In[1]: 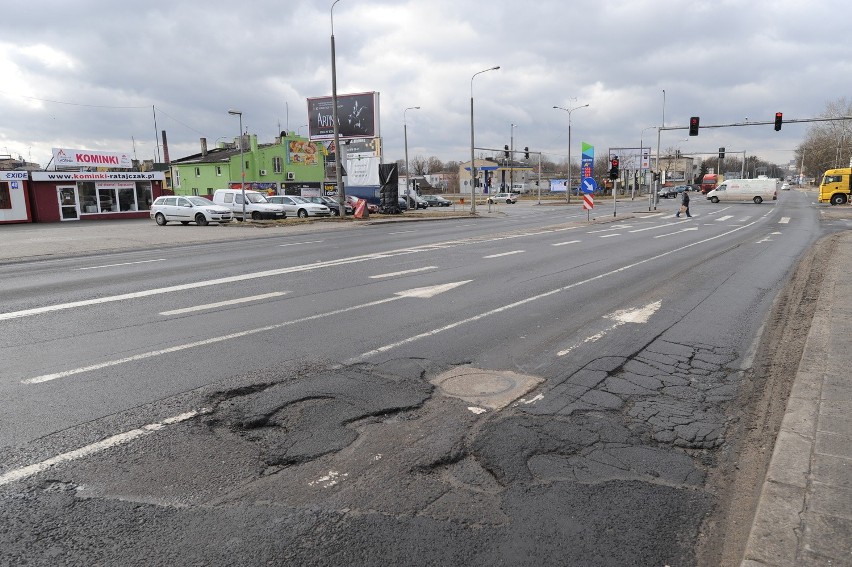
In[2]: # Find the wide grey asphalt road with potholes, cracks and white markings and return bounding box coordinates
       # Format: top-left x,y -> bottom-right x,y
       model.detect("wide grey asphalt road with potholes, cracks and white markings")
0,192 -> 840,565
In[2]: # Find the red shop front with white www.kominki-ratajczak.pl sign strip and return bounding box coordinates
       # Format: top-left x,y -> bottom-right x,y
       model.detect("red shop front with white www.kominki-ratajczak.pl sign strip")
30,171 -> 165,222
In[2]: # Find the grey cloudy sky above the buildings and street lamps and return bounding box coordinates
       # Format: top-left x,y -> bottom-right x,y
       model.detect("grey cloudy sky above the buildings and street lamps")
0,0 -> 852,171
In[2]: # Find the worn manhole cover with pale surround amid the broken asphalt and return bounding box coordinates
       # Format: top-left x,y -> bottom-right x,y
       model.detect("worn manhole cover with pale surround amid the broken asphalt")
431,367 -> 542,409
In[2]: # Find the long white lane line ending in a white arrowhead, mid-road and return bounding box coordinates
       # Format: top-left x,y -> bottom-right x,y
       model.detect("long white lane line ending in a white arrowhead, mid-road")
21,280 -> 473,384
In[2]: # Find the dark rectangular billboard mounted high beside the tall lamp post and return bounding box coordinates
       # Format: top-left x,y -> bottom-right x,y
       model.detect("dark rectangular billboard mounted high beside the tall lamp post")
308,92 -> 379,140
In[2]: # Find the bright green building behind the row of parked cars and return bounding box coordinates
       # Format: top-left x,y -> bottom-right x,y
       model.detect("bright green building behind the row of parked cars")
170,132 -> 325,196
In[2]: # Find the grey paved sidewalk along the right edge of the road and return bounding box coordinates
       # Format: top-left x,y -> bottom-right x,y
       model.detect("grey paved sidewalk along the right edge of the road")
740,231 -> 852,567
